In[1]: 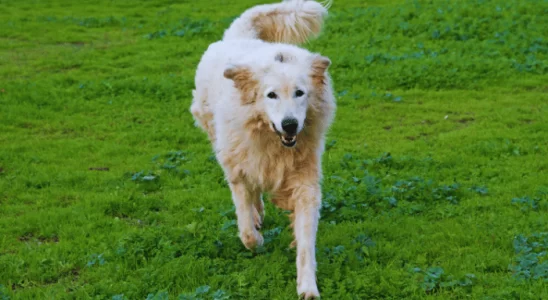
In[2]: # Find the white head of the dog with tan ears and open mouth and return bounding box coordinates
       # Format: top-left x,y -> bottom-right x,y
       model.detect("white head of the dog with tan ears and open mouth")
224,53 -> 331,147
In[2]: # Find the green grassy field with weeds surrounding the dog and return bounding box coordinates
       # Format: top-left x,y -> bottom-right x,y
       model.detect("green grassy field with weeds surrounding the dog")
0,0 -> 548,299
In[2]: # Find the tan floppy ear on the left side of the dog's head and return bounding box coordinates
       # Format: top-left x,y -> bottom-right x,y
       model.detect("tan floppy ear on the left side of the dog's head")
223,66 -> 259,104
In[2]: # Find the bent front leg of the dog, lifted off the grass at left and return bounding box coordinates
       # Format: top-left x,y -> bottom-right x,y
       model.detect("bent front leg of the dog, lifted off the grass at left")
230,182 -> 263,249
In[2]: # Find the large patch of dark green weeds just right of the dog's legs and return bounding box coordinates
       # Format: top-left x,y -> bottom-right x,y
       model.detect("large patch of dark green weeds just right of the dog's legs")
322,153 -> 465,221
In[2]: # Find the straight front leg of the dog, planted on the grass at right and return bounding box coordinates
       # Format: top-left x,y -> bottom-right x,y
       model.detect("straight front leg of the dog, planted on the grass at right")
293,185 -> 321,299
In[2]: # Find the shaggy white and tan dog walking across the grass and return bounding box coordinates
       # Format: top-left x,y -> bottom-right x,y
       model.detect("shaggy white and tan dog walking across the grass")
190,0 -> 335,298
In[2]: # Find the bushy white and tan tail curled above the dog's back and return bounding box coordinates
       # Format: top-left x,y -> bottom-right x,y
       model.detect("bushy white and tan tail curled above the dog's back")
223,0 -> 332,44
